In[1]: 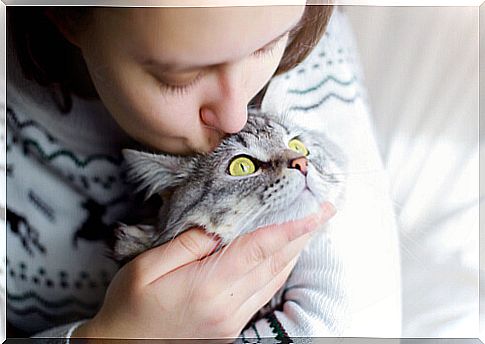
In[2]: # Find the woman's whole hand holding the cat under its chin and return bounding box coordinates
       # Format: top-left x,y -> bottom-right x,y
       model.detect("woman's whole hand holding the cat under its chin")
73,203 -> 335,338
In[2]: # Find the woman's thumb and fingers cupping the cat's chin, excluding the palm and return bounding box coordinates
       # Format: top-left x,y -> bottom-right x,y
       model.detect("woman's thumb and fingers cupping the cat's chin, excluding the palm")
134,203 -> 335,306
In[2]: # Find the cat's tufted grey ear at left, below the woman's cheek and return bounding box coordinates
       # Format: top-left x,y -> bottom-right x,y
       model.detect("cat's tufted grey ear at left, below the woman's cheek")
122,149 -> 193,198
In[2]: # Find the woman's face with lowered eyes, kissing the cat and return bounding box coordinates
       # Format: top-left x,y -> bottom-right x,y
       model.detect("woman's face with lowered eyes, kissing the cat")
73,6 -> 304,154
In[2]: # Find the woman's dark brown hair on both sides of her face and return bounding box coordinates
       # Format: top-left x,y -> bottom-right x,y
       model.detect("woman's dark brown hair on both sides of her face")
7,5 -> 333,113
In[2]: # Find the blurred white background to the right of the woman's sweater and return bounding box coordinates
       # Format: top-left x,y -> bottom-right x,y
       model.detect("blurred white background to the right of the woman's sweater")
342,5 -> 484,338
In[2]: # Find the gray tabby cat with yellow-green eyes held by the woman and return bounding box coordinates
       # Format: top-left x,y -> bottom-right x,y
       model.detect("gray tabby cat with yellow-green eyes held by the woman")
114,112 -> 344,260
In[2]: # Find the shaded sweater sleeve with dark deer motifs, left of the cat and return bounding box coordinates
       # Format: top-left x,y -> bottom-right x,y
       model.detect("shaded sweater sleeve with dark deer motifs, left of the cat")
4,18 -> 130,338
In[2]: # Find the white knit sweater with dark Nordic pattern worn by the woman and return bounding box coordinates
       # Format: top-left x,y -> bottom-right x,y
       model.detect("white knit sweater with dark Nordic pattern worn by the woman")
7,11 -> 400,342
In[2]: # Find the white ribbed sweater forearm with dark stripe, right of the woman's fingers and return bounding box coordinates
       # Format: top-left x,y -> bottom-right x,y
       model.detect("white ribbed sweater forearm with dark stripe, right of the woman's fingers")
238,233 -> 347,343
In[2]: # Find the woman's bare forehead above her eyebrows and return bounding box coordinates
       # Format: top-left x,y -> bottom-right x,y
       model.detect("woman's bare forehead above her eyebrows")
97,6 -> 304,70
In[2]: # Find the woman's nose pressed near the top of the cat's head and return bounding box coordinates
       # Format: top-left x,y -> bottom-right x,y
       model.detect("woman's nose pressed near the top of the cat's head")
200,63 -> 249,134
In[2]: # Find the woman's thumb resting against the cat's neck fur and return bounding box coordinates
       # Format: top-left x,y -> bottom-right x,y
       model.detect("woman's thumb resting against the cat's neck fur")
132,227 -> 219,284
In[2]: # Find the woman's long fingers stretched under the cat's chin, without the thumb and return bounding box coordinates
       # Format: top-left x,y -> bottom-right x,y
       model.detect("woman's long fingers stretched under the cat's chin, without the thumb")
158,205 -> 334,307
